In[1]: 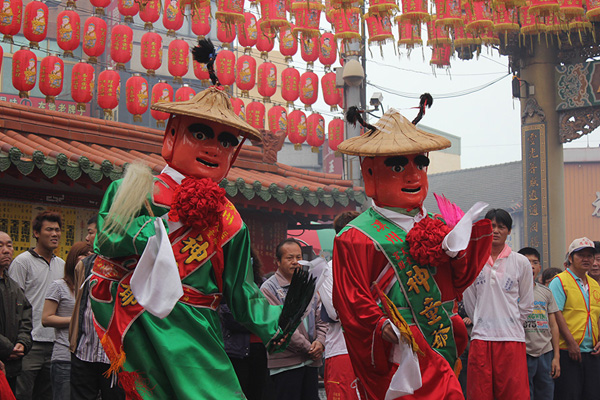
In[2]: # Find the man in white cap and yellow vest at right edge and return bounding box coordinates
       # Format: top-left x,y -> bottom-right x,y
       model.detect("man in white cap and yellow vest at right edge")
549,237 -> 600,400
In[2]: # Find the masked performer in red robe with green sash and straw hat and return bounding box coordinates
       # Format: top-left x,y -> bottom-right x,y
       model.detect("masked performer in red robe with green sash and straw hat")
333,109 -> 491,400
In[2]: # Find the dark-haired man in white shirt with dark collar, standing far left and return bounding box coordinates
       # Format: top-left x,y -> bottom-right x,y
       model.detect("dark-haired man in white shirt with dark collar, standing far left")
8,211 -> 65,400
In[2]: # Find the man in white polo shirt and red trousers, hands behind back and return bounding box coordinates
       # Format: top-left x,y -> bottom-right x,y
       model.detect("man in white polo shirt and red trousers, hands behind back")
463,209 -> 533,400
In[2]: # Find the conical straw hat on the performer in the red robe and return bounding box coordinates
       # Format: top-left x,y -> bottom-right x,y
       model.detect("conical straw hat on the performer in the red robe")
338,108 -> 451,157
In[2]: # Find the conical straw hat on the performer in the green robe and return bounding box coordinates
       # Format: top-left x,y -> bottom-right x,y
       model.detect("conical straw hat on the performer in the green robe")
152,86 -> 262,140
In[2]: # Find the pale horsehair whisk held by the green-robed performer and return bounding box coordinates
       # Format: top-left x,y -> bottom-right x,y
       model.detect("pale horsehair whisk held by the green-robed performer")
98,161 -> 154,245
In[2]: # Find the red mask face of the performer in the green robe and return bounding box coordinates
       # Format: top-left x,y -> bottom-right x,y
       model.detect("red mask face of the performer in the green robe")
162,115 -> 239,182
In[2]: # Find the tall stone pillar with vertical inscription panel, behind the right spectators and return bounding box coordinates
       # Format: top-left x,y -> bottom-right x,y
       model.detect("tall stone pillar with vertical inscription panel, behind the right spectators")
516,41 -> 566,269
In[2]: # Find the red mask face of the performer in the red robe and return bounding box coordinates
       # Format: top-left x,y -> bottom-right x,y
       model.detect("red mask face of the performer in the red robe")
361,153 -> 429,211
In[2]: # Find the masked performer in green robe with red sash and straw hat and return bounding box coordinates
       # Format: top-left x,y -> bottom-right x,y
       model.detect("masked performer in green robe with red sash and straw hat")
90,42 -> 312,400
